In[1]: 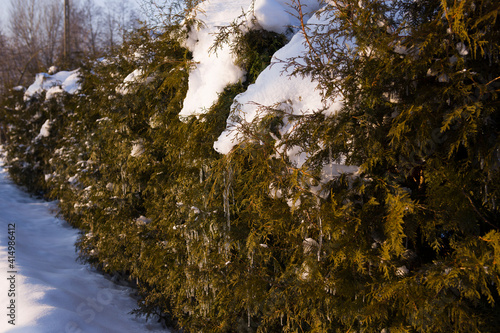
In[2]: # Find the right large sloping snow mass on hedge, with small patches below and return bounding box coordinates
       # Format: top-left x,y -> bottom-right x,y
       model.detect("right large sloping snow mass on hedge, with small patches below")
210,6 -> 359,201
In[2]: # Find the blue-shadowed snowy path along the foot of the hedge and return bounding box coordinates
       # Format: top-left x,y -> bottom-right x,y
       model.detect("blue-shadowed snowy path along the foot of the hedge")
0,156 -> 168,333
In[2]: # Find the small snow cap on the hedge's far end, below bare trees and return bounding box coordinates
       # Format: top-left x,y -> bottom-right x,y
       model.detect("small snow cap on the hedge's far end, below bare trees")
24,70 -> 80,101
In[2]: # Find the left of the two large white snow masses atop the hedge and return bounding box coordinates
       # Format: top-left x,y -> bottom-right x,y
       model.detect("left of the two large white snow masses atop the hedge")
179,0 -> 322,117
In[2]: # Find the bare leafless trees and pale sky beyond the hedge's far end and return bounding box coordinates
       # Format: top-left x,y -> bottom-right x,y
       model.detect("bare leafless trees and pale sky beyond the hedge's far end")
0,0 -> 141,94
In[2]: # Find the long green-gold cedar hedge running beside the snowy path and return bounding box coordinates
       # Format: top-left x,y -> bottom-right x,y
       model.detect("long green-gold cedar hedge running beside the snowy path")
0,0 -> 500,332
